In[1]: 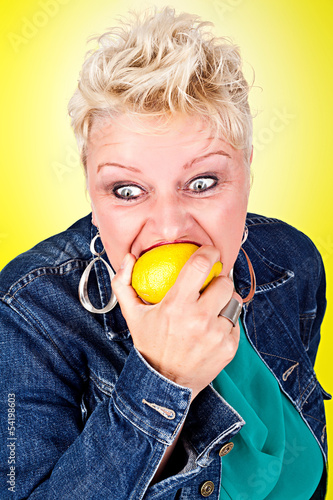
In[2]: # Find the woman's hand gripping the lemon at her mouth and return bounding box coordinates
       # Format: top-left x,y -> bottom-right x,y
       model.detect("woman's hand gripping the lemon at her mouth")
112,246 -> 242,398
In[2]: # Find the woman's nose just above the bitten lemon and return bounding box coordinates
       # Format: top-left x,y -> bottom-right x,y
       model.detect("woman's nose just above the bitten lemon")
146,196 -> 195,241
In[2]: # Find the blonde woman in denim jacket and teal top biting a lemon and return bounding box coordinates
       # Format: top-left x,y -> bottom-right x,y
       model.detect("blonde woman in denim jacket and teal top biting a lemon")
0,8 -> 328,500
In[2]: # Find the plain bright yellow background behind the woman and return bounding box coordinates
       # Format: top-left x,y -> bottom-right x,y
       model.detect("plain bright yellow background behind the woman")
0,0 -> 333,498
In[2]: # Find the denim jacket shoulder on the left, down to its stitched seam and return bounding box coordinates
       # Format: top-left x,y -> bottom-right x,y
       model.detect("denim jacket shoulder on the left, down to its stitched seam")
0,215 -> 91,298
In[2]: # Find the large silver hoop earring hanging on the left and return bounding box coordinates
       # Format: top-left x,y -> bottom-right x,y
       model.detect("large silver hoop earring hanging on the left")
79,233 -> 117,314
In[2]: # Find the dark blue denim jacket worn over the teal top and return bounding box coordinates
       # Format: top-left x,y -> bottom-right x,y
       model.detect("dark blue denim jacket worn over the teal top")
0,214 -> 329,500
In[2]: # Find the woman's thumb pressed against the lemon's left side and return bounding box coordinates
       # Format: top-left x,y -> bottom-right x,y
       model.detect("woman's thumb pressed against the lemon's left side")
112,253 -> 142,319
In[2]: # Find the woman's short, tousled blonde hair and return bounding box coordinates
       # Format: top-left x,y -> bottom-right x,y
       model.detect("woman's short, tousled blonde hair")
68,7 -> 252,165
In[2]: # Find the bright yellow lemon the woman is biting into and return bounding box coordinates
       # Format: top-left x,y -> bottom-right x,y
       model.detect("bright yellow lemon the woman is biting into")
132,243 -> 222,304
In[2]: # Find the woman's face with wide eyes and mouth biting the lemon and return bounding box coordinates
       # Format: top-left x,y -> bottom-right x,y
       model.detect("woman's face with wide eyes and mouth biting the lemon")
87,115 -> 250,275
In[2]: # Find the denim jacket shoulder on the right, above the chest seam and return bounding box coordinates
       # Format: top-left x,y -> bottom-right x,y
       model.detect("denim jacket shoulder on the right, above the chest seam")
246,213 -> 324,286
